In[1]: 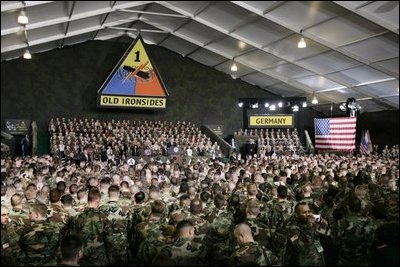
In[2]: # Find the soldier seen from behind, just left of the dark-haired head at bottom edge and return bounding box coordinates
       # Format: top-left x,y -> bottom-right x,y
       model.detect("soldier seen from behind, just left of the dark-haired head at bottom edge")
19,203 -> 60,266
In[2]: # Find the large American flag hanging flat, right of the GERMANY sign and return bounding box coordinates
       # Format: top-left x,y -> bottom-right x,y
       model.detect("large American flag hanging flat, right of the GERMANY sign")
314,117 -> 357,151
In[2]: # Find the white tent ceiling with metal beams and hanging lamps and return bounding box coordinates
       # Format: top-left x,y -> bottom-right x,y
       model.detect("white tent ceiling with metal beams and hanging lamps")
1,1 -> 399,112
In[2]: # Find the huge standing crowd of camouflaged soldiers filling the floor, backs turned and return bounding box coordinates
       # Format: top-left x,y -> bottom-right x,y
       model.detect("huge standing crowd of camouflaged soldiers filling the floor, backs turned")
1,148 -> 399,266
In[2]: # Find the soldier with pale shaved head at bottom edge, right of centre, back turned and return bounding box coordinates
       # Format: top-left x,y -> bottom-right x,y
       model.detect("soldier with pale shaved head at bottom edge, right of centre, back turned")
231,223 -> 279,266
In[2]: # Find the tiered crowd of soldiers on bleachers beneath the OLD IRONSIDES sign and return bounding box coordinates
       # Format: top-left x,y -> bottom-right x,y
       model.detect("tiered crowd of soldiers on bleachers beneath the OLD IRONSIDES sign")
49,118 -> 222,164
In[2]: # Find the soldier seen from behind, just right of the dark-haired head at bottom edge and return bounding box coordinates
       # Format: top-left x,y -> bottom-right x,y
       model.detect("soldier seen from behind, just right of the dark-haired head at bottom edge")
66,188 -> 110,266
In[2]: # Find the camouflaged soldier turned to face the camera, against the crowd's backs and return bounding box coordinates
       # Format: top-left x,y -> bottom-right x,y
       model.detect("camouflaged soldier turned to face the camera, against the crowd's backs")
283,202 -> 325,266
